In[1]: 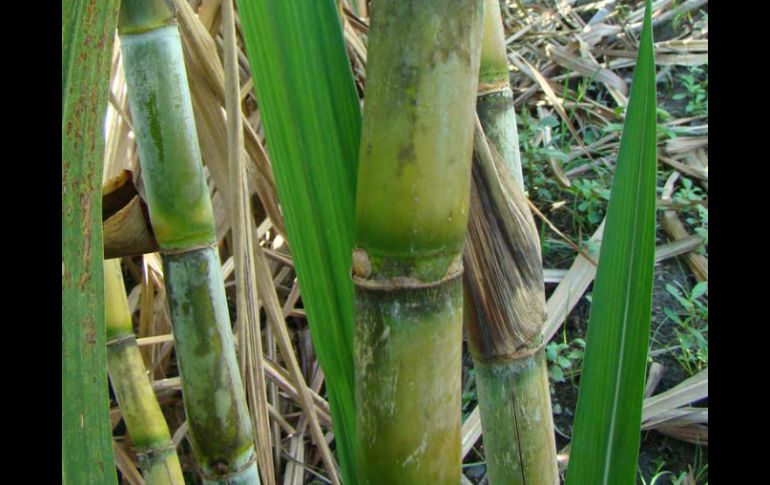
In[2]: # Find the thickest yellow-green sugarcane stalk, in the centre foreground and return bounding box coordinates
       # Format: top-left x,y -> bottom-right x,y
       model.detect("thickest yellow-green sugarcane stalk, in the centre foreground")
353,0 -> 483,484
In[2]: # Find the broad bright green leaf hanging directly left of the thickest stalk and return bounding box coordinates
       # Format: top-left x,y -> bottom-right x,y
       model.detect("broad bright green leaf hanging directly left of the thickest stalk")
238,0 -> 361,484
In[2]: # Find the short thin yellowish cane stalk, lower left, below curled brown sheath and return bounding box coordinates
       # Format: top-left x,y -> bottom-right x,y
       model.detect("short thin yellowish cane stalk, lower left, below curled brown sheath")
104,259 -> 184,485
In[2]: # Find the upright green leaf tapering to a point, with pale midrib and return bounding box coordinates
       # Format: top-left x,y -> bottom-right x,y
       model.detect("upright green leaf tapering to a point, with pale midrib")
567,0 -> 656,485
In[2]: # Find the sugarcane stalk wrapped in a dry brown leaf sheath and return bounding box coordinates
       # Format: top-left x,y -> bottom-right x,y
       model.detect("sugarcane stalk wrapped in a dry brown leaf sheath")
465,0 -> 559,485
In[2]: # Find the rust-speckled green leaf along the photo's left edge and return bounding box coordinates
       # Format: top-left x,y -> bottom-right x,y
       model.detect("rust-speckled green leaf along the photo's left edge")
62,0 -> 118,484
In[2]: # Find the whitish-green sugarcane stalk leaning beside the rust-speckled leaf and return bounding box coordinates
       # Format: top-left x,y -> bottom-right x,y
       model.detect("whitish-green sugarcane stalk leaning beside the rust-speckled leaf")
118,0 -> 259,484
